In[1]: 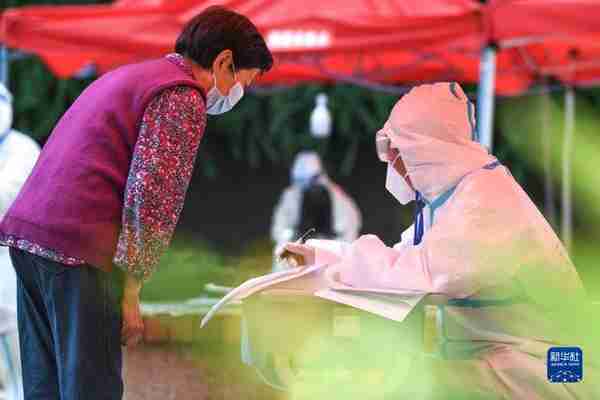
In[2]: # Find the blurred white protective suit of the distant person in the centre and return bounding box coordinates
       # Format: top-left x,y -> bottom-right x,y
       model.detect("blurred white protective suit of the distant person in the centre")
271,152 -> 362,244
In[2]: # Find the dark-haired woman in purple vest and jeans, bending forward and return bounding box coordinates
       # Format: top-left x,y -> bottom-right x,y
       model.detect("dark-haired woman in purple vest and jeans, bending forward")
0,6 -> 273,400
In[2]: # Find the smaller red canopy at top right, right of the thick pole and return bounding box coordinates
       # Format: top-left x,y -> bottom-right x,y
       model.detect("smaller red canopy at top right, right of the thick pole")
486,0 -> 600,85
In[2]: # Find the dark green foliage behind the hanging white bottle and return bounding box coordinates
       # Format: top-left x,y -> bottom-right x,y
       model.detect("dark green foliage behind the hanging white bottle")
210,85 -> 397,174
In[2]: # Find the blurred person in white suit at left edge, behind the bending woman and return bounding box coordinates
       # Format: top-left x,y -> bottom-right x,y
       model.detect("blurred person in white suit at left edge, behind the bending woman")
0,84 -> 40,400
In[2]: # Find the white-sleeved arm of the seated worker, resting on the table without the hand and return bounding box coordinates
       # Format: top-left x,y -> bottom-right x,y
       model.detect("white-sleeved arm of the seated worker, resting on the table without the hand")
332,178 -> 540,297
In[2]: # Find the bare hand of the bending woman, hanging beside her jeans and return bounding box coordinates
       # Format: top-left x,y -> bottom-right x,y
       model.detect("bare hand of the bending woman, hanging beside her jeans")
121,275 -> 144,347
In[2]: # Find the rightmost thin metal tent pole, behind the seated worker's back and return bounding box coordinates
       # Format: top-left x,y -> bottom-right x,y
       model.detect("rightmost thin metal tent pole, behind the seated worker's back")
562,85 -> 575,252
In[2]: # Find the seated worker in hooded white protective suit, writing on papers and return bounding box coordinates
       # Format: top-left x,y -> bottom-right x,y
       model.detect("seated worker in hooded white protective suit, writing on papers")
286,83 -> 600,400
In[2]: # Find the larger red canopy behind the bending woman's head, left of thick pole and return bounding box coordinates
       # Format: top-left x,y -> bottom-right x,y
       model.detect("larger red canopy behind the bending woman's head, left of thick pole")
0,0 -> 481,87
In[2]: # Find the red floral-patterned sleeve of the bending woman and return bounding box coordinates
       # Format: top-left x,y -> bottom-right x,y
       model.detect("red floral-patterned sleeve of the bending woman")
113,86 -> 206,280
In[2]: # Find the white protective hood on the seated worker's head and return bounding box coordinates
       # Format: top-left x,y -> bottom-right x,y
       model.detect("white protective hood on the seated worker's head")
383,82 -> 494,201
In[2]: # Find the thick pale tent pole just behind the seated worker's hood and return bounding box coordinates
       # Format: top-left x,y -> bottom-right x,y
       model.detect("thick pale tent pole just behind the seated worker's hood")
477,45 -> 496,153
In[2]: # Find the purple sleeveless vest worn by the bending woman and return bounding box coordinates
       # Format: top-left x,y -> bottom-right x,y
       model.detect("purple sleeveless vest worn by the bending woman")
0,58 -> 204,271
